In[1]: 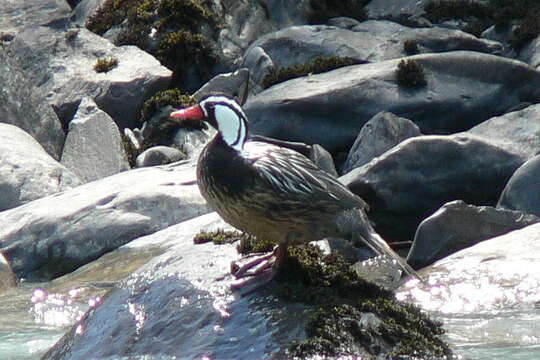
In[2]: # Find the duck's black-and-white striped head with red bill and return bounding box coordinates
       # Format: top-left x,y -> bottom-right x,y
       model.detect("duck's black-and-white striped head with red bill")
170,95 -> 248,151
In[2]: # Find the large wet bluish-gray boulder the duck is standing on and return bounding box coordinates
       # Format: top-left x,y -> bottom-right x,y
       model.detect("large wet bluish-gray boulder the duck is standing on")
42,214 -> 451,360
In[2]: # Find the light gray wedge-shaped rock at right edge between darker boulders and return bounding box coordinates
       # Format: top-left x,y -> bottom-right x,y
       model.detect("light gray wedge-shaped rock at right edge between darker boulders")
467,104 -> 540,157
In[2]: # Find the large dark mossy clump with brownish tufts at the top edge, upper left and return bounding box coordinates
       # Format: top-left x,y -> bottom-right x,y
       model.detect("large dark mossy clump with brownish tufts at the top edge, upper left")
86,0 -> 219,91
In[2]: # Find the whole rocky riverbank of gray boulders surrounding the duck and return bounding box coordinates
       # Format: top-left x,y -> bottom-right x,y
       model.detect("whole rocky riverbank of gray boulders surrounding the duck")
0,0 -> 540,360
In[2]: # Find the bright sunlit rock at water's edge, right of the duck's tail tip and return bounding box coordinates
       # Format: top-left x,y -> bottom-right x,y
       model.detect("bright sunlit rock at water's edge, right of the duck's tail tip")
396,223 -> 540,312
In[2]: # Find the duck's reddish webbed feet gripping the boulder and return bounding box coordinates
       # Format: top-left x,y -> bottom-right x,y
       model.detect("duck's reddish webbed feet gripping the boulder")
231,245 -> 287,293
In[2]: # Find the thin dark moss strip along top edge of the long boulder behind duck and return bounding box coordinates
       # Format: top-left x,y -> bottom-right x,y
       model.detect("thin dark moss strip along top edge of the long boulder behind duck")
262,56 -> 361,89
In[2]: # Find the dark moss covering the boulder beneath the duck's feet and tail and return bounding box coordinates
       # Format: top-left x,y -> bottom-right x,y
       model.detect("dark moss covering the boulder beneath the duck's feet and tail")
202,230 -> 452,360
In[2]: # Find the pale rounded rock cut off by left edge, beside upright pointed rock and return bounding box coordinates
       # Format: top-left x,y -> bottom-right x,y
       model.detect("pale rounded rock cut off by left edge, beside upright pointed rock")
0,124 -> 80,211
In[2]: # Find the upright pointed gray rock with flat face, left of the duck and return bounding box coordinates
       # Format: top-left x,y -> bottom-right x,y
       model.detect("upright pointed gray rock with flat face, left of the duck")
62,97 -> 130,183
